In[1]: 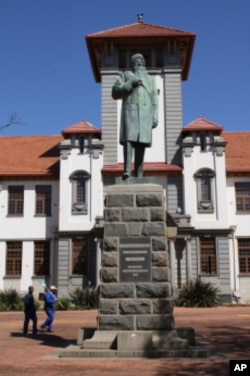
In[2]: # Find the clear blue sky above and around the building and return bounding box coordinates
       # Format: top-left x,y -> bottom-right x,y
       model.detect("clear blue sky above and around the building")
0,0 -> 250,135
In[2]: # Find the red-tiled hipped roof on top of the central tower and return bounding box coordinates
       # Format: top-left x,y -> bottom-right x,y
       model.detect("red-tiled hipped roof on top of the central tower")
86,19 -> 195,82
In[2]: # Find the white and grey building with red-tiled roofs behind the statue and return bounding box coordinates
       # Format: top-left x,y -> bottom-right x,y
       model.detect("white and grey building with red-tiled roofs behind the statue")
0,19 -> 250,302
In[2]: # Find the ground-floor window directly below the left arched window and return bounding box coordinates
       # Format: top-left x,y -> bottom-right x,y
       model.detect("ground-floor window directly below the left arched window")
71,238 -> 88,275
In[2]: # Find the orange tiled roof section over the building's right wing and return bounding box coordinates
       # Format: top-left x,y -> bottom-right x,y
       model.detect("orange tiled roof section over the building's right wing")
224,132 -> 250,174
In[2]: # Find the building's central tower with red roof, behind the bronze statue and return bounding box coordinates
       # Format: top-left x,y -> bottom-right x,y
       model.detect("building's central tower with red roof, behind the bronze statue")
86,15 -> 195,212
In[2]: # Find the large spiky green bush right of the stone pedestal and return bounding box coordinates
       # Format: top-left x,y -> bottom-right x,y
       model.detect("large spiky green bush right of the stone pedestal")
175,278 -> 220,307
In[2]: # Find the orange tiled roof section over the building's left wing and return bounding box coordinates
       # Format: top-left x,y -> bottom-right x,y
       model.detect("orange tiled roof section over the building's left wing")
0,136 -> 63,179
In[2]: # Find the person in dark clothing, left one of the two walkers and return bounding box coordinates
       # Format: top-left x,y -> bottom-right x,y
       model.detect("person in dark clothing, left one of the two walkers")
23,286 -> 39,336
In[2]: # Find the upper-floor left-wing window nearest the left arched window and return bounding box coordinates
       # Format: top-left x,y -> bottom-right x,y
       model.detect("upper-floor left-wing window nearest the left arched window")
35,184 -> 52,217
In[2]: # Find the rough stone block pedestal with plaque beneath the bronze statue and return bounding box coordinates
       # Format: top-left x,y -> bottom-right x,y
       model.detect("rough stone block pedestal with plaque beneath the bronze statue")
98,183 -> 174,331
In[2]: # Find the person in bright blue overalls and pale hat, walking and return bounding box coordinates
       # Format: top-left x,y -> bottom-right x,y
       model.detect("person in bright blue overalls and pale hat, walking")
41,286 -> 57,332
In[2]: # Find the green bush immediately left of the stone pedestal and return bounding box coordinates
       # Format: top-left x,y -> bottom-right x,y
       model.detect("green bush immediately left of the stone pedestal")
69,287 -> 99,309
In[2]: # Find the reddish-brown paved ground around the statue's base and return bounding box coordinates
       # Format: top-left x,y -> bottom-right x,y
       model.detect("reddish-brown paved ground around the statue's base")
0,306 -> 250,376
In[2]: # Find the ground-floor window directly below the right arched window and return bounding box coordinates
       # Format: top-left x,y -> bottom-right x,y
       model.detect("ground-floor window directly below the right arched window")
200,237 -> 217,275
